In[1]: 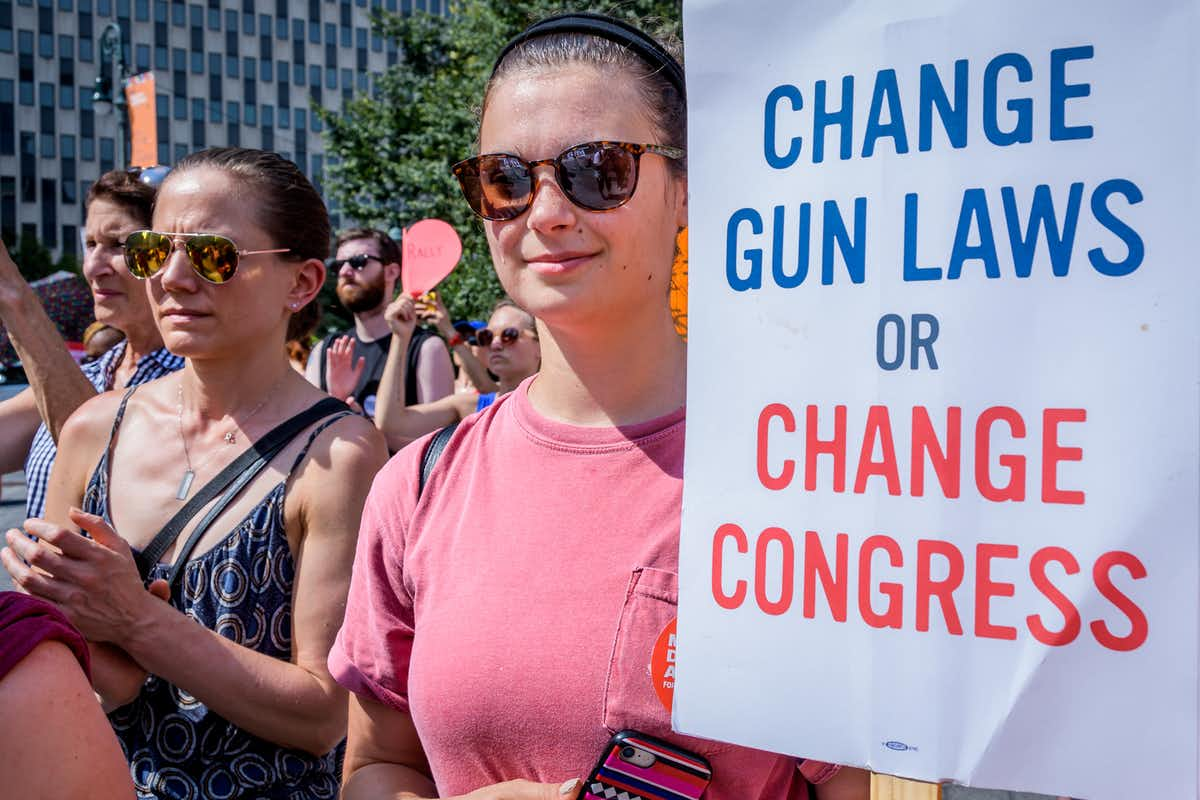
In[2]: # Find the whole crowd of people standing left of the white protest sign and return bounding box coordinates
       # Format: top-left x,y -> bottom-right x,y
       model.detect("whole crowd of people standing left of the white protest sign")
0,14 -> 869,800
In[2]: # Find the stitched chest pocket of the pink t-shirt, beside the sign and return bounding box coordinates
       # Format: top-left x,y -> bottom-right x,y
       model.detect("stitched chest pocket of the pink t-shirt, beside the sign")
604,567 -> 734,756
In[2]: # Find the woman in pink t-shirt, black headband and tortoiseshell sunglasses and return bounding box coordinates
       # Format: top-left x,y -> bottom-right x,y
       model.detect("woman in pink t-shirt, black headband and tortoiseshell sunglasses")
330,14 -> 869,800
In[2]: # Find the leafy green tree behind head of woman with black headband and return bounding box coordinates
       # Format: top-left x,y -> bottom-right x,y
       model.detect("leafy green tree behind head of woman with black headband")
314,0 -> 680,326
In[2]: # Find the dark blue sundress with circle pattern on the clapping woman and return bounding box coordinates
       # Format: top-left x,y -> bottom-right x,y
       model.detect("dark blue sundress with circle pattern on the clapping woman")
83,390 -> 344,800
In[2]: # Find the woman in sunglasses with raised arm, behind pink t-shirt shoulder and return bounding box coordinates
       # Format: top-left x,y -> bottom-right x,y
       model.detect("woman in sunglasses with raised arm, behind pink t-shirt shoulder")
376,295 -> 541,451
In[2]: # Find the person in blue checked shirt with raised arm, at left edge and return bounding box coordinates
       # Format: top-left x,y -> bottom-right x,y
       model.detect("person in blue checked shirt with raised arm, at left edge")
0,169 -> 184,517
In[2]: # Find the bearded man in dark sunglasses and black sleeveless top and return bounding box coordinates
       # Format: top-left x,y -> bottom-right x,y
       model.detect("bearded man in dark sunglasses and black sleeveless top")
305,228 -> 454,417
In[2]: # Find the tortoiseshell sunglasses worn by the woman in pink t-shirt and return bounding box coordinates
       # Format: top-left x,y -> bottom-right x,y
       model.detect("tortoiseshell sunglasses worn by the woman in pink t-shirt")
451,142 -> 684,221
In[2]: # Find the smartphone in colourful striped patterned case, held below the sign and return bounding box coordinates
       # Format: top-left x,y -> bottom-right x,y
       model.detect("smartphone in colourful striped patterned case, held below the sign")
580,730 -> 713,800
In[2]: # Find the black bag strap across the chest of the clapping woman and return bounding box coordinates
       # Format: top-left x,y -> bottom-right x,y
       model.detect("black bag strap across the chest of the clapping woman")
133,397 -> 347,581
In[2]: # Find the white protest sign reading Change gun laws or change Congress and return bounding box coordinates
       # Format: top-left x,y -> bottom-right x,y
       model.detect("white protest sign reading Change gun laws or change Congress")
674,0 -> 1200,800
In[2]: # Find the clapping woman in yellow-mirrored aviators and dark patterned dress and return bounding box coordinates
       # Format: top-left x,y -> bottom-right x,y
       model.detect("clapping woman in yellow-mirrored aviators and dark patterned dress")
4,148 -> 386,798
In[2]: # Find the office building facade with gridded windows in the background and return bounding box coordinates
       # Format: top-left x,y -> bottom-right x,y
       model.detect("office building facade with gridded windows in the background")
0,0 -> 448,257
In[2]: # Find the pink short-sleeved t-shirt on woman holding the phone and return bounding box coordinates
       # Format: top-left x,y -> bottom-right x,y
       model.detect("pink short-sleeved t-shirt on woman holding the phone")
329,380 -> 817,800
